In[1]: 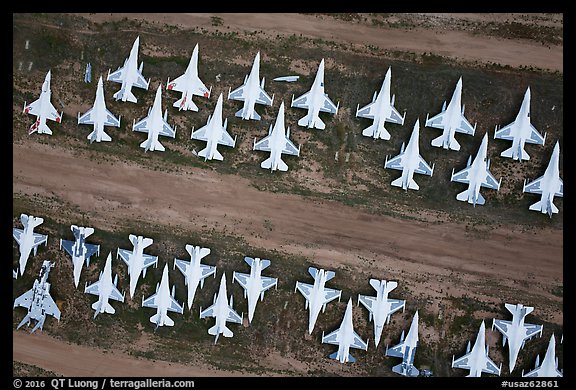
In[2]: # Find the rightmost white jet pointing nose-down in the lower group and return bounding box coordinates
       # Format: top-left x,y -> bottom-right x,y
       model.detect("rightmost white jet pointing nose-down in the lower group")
492,303 -> 543,372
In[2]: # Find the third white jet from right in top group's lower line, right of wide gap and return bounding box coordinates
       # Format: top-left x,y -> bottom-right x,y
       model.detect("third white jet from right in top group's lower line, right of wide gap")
384,119 -> 434,191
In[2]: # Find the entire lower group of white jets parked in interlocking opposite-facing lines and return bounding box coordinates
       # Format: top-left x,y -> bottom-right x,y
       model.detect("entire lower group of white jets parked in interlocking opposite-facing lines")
13,214 -> 562,377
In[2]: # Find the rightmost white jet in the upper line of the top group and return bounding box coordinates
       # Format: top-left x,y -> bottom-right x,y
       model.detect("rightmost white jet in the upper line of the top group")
494,87 -> 546,161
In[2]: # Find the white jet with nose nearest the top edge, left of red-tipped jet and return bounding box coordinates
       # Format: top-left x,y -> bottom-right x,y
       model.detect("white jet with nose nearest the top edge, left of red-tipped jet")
106,37 -> 150,103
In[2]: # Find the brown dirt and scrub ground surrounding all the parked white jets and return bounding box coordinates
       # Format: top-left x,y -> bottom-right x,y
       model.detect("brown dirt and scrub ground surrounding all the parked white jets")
13,14 -> 563,377
